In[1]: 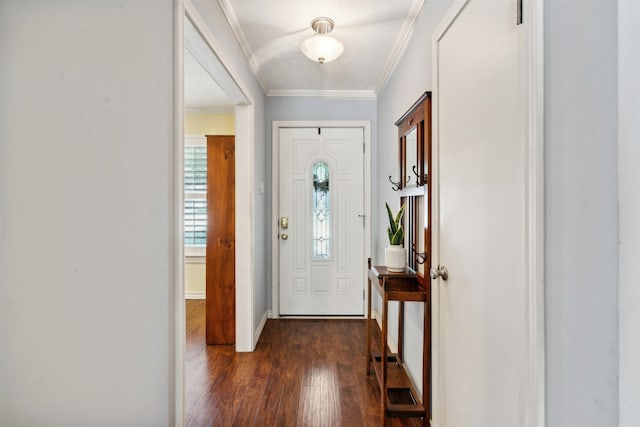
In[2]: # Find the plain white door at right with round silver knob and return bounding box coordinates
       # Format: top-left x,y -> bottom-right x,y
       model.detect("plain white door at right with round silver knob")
432,0 -> 535,427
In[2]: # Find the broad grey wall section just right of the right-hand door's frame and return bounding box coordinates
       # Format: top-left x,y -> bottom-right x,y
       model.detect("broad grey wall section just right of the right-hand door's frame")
544,0 -> 620,427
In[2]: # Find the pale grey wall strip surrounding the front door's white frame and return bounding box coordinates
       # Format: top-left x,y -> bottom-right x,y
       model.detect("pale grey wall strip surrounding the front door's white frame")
265,96 -> 377,309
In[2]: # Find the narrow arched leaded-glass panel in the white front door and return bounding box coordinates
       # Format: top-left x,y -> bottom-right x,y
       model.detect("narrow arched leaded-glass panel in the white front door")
311,162 -> 331,259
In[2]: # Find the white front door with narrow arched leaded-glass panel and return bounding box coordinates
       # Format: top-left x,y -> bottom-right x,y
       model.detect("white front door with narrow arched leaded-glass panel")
279,128 -> 365,316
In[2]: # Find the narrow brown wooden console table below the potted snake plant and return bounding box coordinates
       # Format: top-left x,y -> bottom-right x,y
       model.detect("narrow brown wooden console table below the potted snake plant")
367,261 -> 431,426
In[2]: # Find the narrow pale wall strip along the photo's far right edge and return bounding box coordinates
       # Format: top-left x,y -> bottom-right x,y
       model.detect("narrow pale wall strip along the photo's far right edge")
618,0 -> 640,427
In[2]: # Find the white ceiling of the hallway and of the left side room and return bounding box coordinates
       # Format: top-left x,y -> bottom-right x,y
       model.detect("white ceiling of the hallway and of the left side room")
185,0 -> 425,112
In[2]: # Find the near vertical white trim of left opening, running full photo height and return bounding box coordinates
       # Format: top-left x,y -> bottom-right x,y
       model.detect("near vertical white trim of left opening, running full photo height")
172,0 -> 187,427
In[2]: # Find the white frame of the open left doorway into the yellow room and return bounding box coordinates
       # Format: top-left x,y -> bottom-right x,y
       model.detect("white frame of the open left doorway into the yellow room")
175,0 -> 259,426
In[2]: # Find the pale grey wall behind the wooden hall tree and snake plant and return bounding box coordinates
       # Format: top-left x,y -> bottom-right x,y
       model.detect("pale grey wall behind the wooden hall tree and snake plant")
371,0 -> 453,390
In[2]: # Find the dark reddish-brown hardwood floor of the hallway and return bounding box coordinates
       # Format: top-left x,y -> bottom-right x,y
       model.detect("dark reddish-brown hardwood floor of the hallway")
186,300 -> 421,427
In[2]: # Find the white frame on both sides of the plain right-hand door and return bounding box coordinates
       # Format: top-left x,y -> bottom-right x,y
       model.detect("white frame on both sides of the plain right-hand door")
431,0 -> 545,427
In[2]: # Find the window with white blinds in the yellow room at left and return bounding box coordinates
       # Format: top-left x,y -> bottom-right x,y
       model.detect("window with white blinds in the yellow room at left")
184,137 -> 207,249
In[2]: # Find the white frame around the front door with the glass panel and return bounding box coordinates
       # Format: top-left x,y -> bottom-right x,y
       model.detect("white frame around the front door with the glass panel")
270,120 -> 371,319
